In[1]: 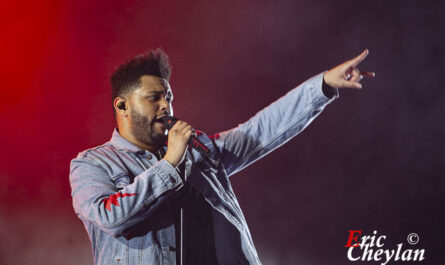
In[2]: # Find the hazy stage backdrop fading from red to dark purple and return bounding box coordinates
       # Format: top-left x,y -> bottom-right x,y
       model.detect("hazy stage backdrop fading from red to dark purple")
0,0 -> 445,265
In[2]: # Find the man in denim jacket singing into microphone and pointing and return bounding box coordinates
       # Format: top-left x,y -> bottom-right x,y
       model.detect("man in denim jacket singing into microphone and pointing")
70,49 -> 374,265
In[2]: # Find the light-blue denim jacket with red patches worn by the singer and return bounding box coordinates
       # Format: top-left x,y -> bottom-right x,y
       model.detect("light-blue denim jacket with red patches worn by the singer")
70,73 -> 338,265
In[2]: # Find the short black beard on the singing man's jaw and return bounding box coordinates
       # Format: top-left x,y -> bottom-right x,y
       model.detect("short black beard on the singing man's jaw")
131,110 -> 167,147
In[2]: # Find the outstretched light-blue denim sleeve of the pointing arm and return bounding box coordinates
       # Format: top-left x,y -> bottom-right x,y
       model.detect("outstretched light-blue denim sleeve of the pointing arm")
212,73 -> 338,176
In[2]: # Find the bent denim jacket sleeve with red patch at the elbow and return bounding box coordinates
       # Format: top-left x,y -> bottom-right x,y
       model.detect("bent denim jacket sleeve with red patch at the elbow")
70,157 -> 183,237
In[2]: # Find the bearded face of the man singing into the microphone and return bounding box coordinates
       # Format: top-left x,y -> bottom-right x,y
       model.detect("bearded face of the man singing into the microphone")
129,75 -> 173,146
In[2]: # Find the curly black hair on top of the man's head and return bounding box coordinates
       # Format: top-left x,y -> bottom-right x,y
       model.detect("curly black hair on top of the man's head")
110,48 -> 171,109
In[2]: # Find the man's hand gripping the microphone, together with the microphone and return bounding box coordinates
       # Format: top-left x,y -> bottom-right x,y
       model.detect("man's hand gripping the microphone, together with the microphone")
164,116 -> 210,167
